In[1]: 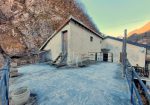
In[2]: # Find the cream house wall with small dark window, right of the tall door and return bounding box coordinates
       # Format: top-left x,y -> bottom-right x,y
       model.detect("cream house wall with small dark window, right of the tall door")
68,21 -> 102,63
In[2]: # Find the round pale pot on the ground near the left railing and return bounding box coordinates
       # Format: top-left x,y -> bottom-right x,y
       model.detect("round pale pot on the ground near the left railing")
12,87 -> 30,105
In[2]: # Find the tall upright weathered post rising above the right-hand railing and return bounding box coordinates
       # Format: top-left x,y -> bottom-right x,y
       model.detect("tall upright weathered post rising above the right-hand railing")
122,29 -> 127,77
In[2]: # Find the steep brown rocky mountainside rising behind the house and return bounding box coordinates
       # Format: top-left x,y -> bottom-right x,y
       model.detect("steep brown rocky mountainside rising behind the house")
0,0 -> 98,56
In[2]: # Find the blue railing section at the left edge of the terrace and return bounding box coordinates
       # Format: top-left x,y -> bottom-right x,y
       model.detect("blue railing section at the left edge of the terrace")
0,59 -> 10,105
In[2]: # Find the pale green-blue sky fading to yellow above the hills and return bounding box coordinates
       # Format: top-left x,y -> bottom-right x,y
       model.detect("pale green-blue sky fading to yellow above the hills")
80,0 -> 150,36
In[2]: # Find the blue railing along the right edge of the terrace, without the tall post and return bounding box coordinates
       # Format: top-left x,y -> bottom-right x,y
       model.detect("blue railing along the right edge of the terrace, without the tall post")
125,60 -> 150,105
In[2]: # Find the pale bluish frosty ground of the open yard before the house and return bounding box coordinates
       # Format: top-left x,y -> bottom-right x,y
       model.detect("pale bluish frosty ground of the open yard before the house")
10,63 -> 130,105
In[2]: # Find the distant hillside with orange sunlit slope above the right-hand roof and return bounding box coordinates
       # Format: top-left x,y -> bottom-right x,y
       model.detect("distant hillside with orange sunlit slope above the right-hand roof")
128,22 -> 150,44
